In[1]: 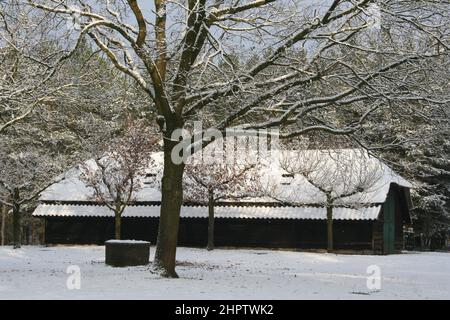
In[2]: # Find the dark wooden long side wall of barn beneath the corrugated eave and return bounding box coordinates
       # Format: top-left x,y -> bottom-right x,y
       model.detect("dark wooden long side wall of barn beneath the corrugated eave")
46,217 -> 373,250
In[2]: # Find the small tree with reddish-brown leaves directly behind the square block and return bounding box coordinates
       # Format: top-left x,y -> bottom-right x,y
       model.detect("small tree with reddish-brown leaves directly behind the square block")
80,120 -> 156,239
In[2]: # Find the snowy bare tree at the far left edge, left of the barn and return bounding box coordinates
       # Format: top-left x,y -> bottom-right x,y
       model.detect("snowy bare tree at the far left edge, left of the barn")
0,0 -> 155,247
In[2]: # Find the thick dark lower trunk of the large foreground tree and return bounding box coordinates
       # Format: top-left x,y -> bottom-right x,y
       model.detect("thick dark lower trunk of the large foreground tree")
155,137 -> 184,278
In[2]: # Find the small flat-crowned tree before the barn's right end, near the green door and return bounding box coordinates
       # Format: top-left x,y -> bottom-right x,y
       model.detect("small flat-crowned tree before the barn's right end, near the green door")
280,149 -> 382,252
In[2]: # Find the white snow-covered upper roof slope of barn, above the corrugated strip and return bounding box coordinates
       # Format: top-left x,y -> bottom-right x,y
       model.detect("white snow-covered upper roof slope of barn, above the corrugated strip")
40,149 -> 412,206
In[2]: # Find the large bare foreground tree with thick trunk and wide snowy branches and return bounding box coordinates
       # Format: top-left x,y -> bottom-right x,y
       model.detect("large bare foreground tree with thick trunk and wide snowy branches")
27,0 -> 449,277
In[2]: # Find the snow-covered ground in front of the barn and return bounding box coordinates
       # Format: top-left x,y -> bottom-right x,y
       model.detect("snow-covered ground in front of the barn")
0,246 -> 450,299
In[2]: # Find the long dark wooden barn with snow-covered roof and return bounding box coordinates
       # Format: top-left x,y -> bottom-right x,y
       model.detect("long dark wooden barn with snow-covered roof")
33,149 -> 411,254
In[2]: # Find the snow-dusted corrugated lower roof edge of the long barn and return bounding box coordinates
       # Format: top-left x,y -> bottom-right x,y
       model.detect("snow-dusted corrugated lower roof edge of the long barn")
33,204 -> 381,220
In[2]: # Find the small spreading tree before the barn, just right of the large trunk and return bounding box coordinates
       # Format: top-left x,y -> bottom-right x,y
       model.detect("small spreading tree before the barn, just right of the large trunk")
184,146 -> 258,250
